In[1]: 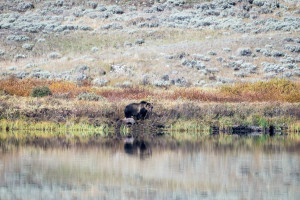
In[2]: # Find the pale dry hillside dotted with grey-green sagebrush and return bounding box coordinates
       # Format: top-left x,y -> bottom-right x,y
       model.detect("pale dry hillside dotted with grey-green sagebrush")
0,0 -> 300,87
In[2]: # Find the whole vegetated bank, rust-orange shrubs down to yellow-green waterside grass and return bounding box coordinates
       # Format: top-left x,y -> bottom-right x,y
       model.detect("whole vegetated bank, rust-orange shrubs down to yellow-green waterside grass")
0,78 -> 300,134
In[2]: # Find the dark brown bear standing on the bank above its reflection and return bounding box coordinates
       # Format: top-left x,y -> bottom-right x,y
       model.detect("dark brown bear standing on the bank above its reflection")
124,101 -> 153,120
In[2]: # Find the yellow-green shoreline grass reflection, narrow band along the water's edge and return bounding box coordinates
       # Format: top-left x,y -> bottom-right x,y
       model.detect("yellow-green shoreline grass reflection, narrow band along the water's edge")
0,127 -> 300,152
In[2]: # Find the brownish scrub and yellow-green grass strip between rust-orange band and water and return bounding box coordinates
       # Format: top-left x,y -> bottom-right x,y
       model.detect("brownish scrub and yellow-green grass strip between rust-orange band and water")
0,96 -> 300,132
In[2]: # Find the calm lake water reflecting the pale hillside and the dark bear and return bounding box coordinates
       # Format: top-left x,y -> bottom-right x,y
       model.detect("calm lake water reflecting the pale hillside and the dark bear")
0,136 -> 300,200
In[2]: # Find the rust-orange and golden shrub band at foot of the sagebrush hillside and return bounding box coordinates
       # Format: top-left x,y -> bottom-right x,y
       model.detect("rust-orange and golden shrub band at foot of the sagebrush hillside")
0,78 -> 300,103
